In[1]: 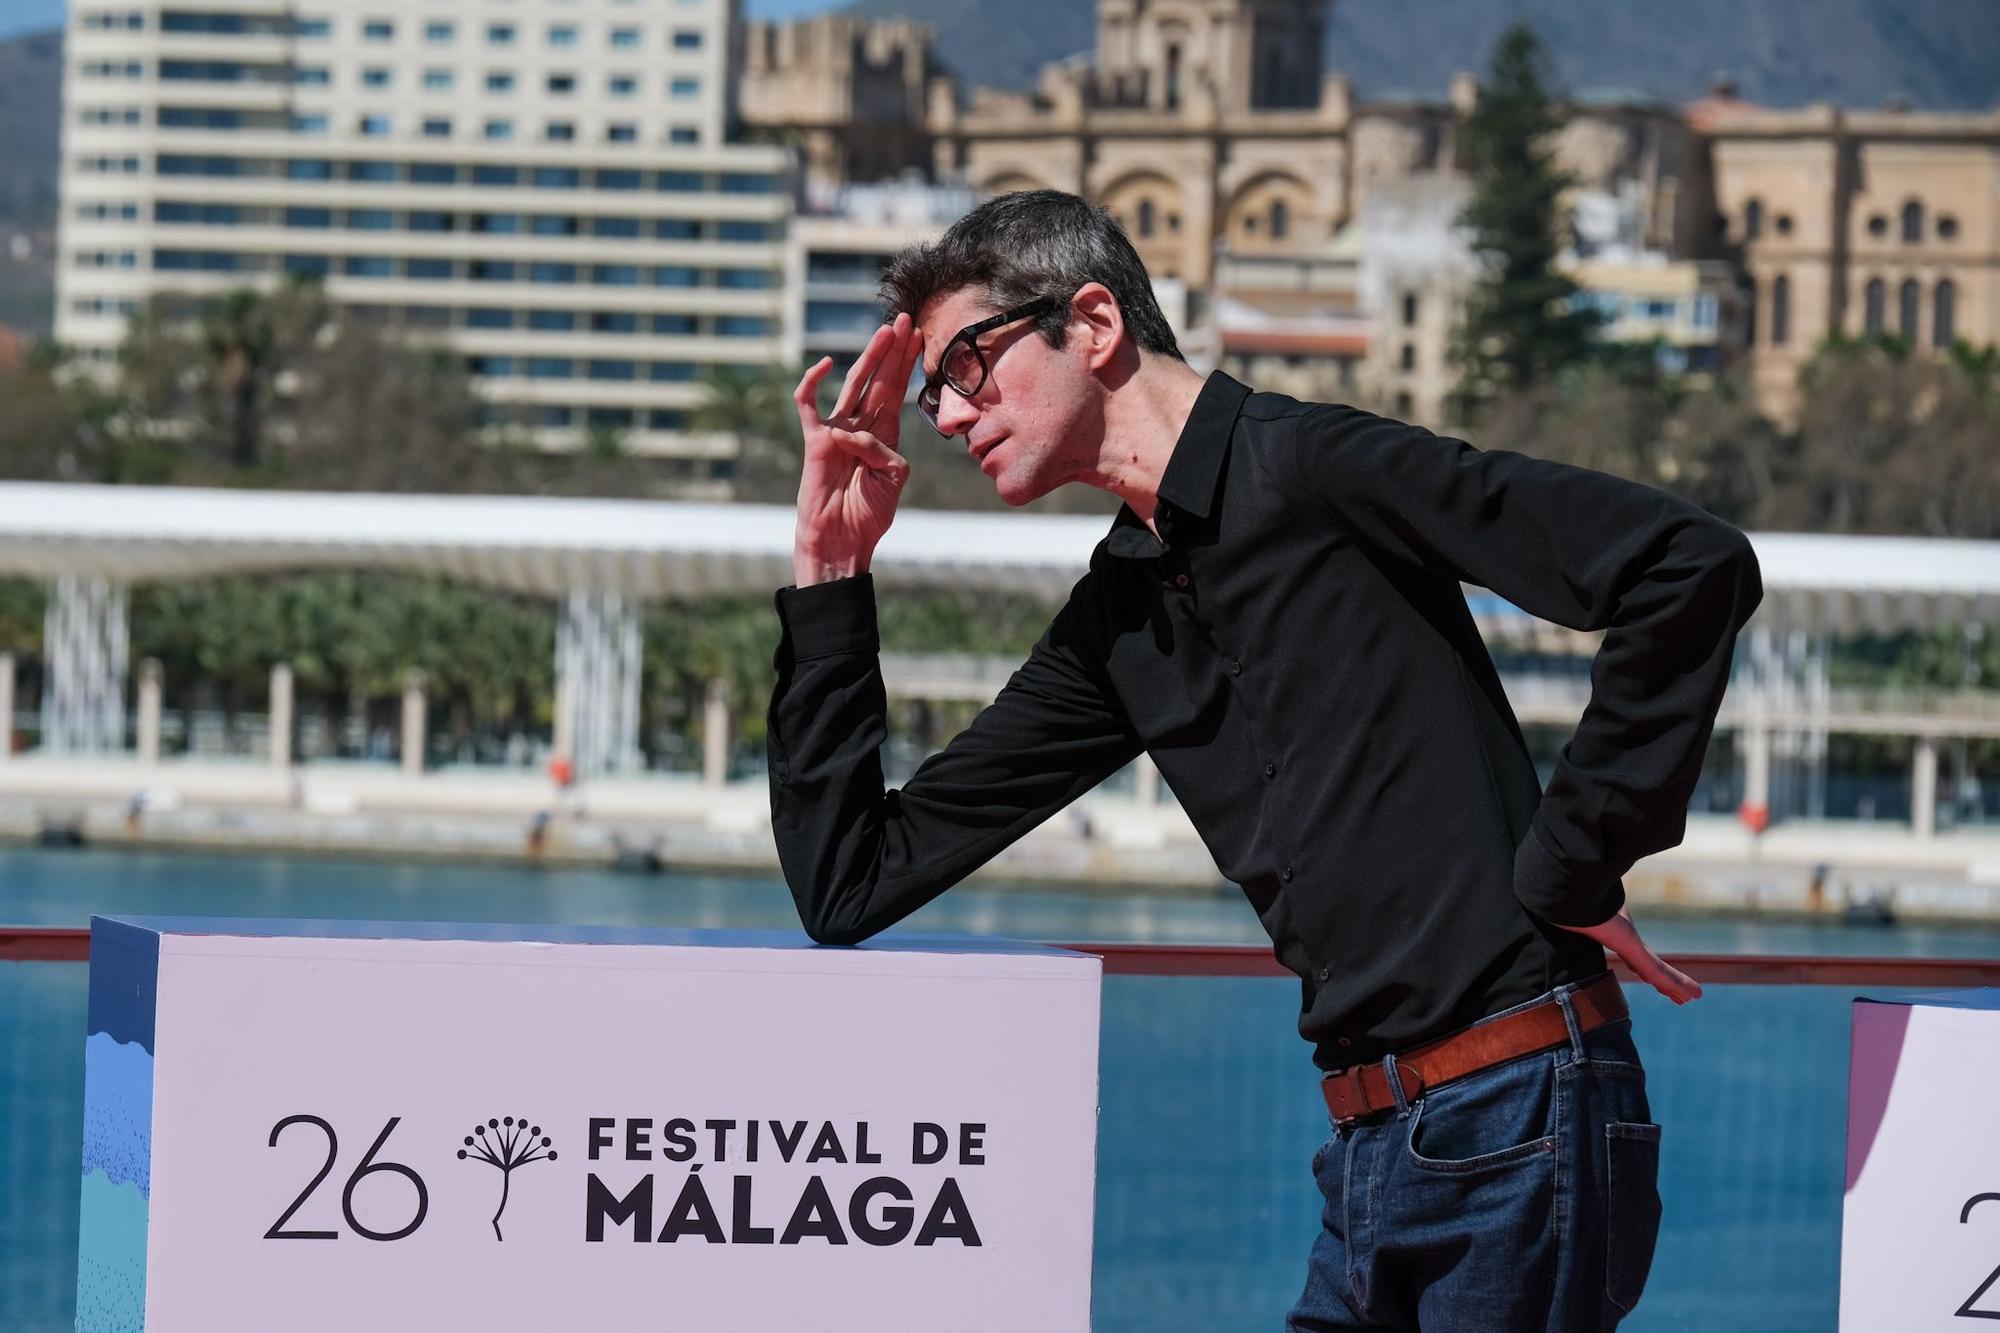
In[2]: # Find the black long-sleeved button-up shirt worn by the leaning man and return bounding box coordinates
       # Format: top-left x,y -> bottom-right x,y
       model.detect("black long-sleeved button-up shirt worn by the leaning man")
770,374 -> 1762,1069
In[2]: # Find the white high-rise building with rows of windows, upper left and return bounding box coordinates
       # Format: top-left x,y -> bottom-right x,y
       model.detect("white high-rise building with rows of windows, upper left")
56,0 -> 790,480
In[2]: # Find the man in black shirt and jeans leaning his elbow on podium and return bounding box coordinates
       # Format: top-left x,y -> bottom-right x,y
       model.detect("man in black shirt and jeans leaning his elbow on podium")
770,190 -> 1762,1333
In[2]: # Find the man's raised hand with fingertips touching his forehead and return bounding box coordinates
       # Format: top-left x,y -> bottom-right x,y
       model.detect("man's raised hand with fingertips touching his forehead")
792,314 -> 924,588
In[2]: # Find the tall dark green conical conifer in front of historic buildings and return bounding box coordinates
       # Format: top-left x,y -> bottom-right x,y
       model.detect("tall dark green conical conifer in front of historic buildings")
1452,22 -> 1600,420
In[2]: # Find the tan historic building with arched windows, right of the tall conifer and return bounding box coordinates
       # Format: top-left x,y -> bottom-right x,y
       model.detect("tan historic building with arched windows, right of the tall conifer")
1690,98 -> 2000,420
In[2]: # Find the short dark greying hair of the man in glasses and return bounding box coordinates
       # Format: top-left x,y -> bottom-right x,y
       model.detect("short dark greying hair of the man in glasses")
882,190 -> 1186,360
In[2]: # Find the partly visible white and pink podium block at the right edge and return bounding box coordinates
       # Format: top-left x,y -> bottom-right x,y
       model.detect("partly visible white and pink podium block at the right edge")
1840,989 -> 2000,1333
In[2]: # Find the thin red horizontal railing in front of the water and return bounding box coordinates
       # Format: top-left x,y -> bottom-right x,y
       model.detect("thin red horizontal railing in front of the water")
0,927 -> 2000,987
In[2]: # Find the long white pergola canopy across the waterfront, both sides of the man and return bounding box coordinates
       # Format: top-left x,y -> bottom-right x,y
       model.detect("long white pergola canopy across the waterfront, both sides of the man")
0,482 -> 2000,634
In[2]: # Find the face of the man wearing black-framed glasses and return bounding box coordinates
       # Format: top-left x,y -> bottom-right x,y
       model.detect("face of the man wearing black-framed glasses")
918,288 -> 1096,504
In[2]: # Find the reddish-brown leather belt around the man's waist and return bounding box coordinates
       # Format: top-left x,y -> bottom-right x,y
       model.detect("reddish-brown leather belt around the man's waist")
1320,973 -> 1630,1127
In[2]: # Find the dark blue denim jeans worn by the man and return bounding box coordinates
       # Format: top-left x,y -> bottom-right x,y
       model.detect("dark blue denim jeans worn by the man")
1284,983 -> 1660,1333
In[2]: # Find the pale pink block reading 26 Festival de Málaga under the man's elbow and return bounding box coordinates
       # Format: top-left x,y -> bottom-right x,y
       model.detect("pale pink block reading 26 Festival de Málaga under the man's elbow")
76,917 -> 1104,1333
